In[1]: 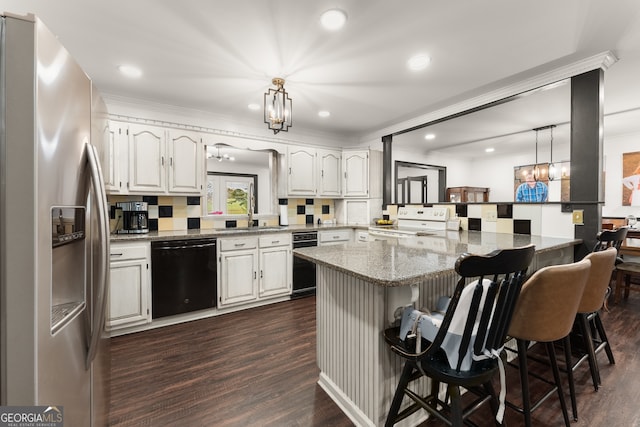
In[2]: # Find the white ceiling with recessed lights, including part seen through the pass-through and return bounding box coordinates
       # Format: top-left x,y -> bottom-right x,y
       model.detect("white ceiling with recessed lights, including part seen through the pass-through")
0,0 -> 640,154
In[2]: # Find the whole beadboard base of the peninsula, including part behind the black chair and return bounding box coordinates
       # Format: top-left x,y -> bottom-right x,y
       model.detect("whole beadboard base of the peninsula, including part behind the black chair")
316,265 -> 457,426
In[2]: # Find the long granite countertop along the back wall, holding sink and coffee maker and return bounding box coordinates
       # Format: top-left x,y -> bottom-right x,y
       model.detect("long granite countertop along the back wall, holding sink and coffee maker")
110,224 -> 368,242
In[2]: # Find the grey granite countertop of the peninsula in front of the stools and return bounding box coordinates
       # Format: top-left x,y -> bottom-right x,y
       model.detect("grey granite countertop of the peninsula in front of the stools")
293,231 -> 581,286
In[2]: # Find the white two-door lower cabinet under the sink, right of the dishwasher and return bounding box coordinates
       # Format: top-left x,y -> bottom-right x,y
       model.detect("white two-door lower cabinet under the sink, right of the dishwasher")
218,233 -> 293,308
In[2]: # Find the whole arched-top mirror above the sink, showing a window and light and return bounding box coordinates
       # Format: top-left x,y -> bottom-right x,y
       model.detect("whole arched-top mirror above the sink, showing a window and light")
204,144 -> 277,217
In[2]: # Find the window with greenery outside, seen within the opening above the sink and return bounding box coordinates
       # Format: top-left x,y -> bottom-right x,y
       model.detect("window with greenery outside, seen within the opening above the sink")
205,172 -> 258,215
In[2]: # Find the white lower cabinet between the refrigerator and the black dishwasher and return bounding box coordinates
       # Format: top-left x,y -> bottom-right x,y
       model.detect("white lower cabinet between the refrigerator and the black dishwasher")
106,242 -> 151,331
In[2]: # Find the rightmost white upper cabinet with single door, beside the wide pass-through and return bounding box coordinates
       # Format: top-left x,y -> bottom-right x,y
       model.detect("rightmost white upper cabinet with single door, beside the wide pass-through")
342,150 -> 382,198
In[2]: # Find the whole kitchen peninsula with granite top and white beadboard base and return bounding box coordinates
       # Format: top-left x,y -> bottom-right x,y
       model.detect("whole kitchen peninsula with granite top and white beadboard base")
294,231 -> 580,426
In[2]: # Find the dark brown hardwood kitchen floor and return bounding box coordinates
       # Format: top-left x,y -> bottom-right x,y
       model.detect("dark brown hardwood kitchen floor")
109,293 -> 640,427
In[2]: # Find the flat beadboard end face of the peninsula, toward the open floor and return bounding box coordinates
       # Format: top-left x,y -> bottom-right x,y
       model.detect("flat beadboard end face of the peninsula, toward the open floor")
316,265 -> 384,425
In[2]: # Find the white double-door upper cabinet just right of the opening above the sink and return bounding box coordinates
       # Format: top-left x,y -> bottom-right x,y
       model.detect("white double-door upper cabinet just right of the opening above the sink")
278,146 -> 342,198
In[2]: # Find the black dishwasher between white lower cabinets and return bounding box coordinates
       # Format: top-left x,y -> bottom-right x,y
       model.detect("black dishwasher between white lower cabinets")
151,239 -> 218,319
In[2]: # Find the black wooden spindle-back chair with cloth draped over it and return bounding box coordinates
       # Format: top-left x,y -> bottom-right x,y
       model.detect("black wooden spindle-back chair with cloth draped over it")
383,245 -> 535,426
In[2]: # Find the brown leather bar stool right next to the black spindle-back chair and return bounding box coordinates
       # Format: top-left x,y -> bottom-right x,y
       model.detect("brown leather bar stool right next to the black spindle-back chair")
507,260 -> 591,427
